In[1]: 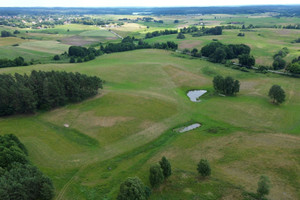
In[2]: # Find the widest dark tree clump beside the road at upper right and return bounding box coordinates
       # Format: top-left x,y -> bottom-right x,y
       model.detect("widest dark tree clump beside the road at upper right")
201,42 -> 251,63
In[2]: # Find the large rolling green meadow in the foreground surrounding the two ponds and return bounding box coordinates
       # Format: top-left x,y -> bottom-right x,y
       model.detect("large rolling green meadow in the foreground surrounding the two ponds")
0,48 -> 300,200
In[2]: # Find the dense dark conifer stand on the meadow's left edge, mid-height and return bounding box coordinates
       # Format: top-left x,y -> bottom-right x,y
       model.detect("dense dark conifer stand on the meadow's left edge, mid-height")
0,71 -> 102,116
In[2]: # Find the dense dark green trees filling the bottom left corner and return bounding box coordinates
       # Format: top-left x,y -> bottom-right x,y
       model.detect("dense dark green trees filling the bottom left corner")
0,134 -> 54,200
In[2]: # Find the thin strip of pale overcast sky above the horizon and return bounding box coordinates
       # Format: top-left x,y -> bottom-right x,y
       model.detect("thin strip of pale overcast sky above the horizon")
0,0 -> 300,7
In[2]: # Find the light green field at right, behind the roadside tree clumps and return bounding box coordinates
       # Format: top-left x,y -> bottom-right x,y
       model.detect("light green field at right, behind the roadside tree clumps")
146,29 -> 300,65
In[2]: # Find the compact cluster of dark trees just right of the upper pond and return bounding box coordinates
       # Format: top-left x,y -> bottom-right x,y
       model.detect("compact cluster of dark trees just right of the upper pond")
213,75 -> 240,95
